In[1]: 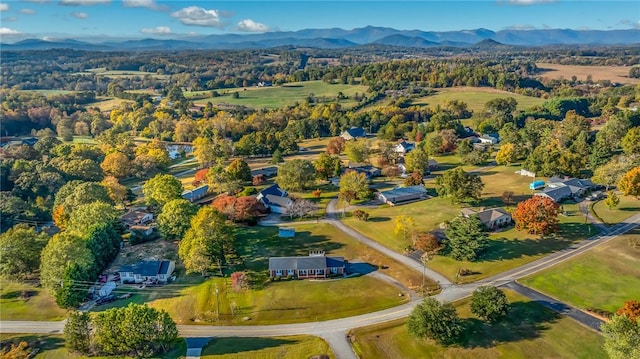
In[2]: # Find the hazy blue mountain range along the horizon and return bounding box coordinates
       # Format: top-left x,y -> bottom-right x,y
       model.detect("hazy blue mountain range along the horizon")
1,26 -> 640,51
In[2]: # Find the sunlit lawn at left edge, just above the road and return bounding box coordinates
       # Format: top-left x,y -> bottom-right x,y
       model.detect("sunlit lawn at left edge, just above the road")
0,280 -> 67,320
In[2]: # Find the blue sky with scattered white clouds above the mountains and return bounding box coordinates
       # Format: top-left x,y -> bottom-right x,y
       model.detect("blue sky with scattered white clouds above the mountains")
0,0 -> 640,41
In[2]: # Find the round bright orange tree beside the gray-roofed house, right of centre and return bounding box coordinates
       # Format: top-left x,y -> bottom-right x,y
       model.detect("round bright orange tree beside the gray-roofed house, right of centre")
512,196 -> 560,235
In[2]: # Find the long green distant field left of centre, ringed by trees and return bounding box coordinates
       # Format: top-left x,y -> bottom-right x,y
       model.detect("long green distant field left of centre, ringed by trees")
192,81 -> 367,108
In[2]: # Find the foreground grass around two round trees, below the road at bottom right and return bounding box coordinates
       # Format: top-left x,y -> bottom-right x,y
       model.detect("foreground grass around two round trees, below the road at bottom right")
351,291 -> 607,359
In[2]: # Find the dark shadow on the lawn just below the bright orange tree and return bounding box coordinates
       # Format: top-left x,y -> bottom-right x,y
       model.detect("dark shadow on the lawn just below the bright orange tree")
480,238 -> 571,261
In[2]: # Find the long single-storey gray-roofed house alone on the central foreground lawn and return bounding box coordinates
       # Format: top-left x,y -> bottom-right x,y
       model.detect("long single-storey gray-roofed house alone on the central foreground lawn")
269,251 -> 346,279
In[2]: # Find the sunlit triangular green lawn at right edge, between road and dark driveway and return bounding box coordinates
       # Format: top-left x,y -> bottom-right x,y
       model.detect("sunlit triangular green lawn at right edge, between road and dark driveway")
521,228 -> 640,312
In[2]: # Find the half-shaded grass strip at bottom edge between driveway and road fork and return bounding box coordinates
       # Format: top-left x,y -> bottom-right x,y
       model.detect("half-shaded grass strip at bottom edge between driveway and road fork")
201,335 -> 335,359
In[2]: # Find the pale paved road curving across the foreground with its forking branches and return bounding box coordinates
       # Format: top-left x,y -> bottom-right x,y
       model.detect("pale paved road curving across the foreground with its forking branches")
0,211 -> 640,359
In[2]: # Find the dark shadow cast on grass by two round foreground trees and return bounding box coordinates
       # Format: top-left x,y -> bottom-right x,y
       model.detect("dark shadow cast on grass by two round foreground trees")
457,302 -> 560,348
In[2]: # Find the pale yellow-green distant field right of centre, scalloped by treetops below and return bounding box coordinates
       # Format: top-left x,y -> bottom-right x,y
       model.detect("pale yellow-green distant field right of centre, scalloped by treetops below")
413,87 -> 544,111
